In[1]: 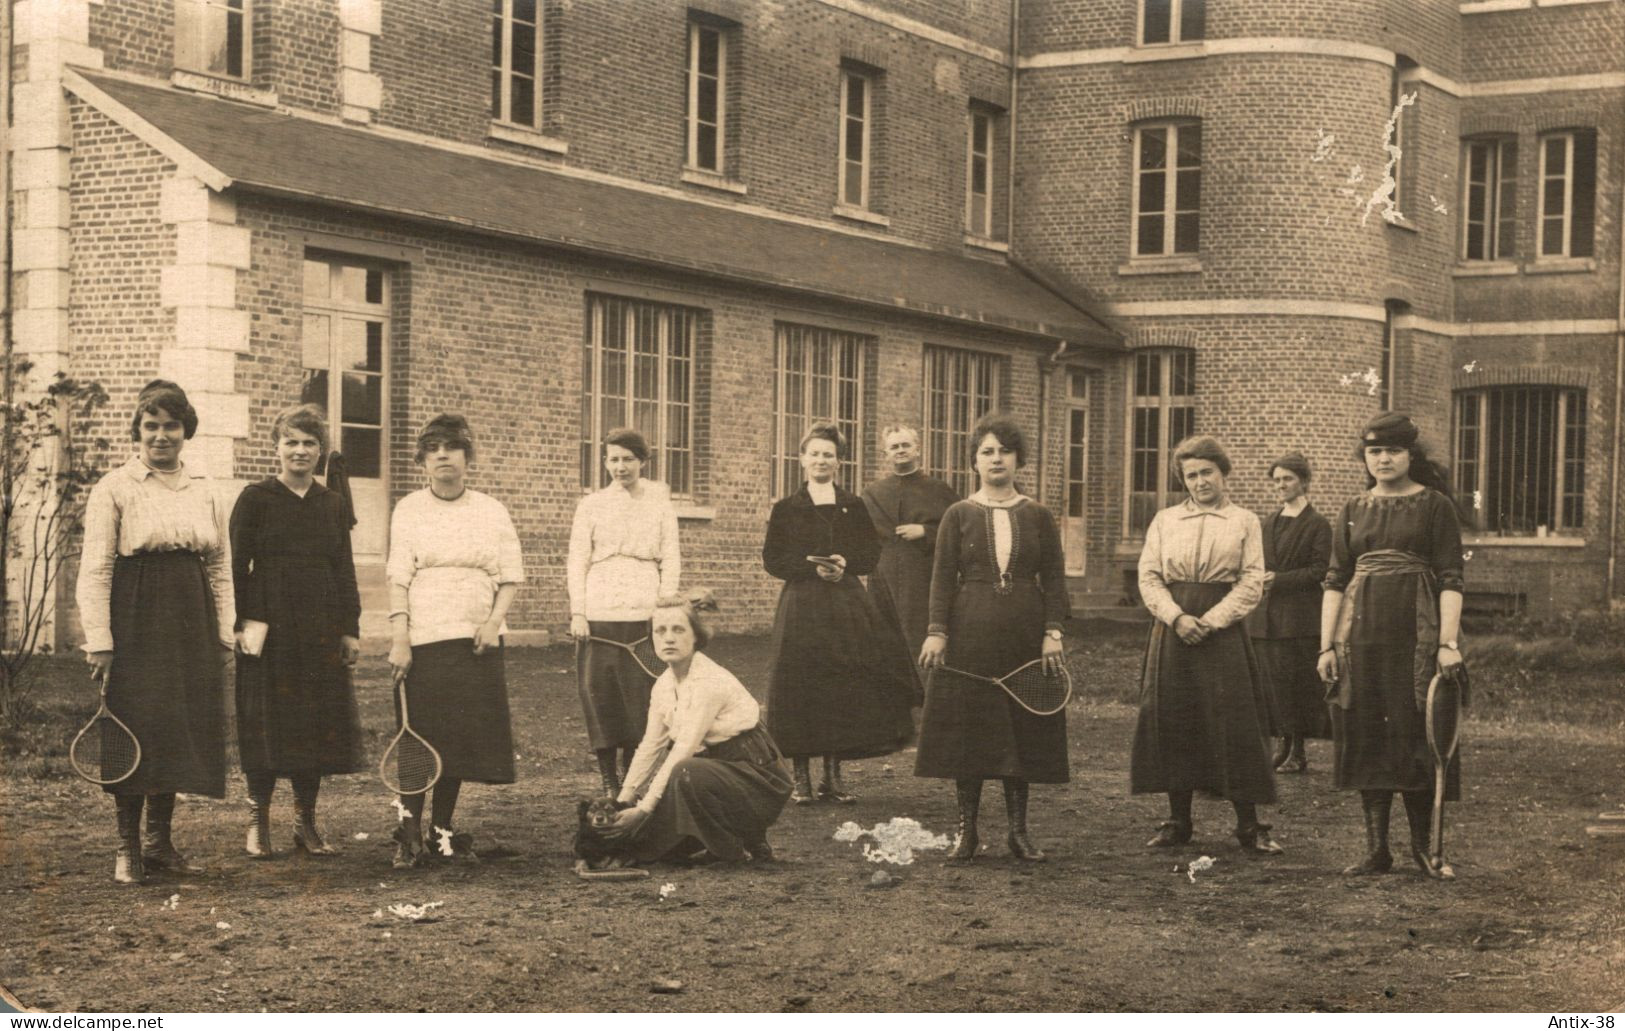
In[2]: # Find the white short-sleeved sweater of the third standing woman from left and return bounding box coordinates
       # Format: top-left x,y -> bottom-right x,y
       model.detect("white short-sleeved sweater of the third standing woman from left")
387,488 -> 525,644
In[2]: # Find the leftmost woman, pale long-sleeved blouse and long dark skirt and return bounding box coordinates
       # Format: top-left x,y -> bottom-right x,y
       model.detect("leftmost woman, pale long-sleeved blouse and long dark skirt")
76,379 -> 237,885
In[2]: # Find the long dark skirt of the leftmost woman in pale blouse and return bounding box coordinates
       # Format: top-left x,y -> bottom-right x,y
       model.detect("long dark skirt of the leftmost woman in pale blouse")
106,551 -> 226,798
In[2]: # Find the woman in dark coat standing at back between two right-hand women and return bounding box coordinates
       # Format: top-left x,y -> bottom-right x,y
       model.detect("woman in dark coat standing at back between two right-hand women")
1248,450 -> 1331,772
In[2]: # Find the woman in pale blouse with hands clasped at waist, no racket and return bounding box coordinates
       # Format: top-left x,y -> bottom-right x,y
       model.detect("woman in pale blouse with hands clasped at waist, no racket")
1129,437 -> 1281,854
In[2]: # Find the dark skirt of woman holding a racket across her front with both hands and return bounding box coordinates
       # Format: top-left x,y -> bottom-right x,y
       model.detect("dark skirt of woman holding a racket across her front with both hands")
915,582 -> 1071,784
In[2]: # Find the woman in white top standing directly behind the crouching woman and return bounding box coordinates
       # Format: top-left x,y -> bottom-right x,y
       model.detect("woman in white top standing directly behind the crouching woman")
567,428 -> 681,797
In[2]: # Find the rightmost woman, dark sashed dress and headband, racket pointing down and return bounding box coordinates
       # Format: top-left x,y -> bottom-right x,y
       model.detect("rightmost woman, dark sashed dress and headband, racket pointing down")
1320,411 -> 1463,878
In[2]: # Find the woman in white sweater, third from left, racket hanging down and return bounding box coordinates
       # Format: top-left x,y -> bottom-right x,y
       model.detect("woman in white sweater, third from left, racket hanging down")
387,415 -> 525,868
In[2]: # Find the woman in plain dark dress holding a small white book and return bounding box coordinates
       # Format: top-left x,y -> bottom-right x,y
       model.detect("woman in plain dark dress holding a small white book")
231,405 -> 362,859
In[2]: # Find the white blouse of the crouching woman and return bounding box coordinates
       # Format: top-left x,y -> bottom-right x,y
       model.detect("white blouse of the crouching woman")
621,652 -> 762,813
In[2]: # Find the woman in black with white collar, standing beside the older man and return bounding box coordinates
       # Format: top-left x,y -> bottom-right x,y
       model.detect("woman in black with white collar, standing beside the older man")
762,423 -> 917,805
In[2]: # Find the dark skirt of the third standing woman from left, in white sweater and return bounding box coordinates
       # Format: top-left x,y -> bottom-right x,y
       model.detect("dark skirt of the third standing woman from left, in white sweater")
395,637 -> 514,784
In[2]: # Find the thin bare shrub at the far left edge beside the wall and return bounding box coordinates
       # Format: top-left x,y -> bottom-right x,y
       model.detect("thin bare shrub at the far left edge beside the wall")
0,358 -> 109,722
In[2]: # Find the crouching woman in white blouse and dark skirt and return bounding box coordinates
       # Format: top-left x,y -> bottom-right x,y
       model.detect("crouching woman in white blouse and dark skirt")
606,588 -> 790,862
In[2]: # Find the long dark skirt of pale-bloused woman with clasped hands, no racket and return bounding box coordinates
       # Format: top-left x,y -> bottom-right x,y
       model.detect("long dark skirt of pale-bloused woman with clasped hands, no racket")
1129,584 -> 1276,802
